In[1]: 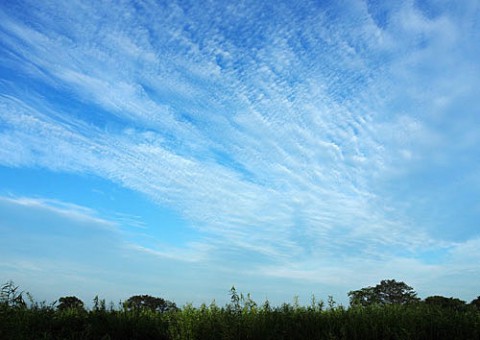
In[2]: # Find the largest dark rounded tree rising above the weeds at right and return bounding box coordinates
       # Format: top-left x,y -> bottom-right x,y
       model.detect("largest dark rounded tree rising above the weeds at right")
348,280 -> 420,306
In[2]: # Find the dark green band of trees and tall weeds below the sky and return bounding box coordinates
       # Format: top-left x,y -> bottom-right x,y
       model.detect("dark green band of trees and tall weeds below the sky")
0,280 -> 480,340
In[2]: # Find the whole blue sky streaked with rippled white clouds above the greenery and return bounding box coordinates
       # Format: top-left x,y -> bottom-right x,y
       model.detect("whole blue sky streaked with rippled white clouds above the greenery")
0,0 -> 480,305
